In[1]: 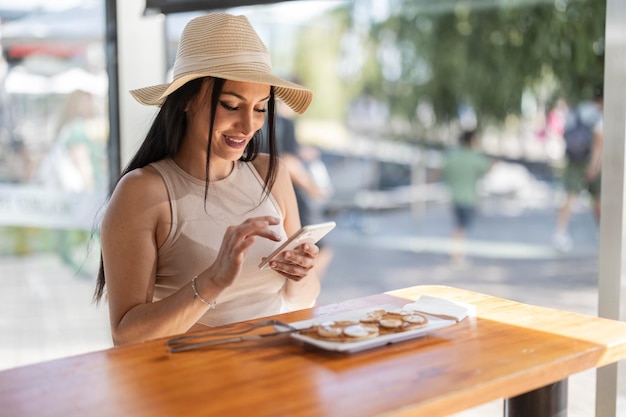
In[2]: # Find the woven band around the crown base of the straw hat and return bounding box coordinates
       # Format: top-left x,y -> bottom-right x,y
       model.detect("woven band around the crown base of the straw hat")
173,52 -> 272,79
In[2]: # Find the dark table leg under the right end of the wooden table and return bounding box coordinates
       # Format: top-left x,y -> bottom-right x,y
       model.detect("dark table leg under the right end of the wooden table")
504,379 -> 567,417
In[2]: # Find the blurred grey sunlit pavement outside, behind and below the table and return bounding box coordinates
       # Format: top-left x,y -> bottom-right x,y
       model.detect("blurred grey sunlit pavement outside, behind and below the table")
320,196 -> 626,417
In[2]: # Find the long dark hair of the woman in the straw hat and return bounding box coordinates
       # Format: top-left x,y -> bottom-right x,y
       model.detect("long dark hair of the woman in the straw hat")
93,77 -> 278,303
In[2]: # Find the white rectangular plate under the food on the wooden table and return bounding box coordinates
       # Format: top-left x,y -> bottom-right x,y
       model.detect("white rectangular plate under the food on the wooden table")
289,304 -> 456,353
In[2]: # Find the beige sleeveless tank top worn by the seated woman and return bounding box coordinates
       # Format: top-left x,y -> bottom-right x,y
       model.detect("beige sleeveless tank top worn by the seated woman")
151,159 -> 286,326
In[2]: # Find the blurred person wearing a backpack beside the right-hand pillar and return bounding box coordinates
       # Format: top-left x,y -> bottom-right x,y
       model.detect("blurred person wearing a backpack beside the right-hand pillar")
553,87 -> 604,252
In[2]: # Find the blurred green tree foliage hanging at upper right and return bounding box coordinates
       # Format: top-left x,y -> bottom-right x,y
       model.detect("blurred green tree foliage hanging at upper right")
336,0 -> 606,128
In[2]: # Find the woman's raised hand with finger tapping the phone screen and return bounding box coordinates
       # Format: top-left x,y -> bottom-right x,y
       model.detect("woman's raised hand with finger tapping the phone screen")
198,216 -> 281,290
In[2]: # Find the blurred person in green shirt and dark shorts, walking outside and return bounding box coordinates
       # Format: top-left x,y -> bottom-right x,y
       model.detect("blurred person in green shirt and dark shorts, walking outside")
442,130 -> 492,266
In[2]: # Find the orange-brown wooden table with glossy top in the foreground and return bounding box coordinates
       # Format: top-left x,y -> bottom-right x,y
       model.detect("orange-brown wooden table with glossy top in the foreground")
0,286 -> 626,417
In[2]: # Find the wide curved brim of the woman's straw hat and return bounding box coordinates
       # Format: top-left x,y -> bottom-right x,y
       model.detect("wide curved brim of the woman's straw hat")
130,70 -> 313,114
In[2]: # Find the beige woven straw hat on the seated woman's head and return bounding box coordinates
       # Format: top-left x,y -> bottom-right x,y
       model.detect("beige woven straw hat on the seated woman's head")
130,13 -> 313,114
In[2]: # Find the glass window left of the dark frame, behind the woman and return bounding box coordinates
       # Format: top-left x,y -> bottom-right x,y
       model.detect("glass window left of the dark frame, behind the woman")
0,0 -> 111,368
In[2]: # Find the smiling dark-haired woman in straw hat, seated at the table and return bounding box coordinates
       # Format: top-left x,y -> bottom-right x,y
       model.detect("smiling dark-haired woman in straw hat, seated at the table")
94,13 -> 319,344
